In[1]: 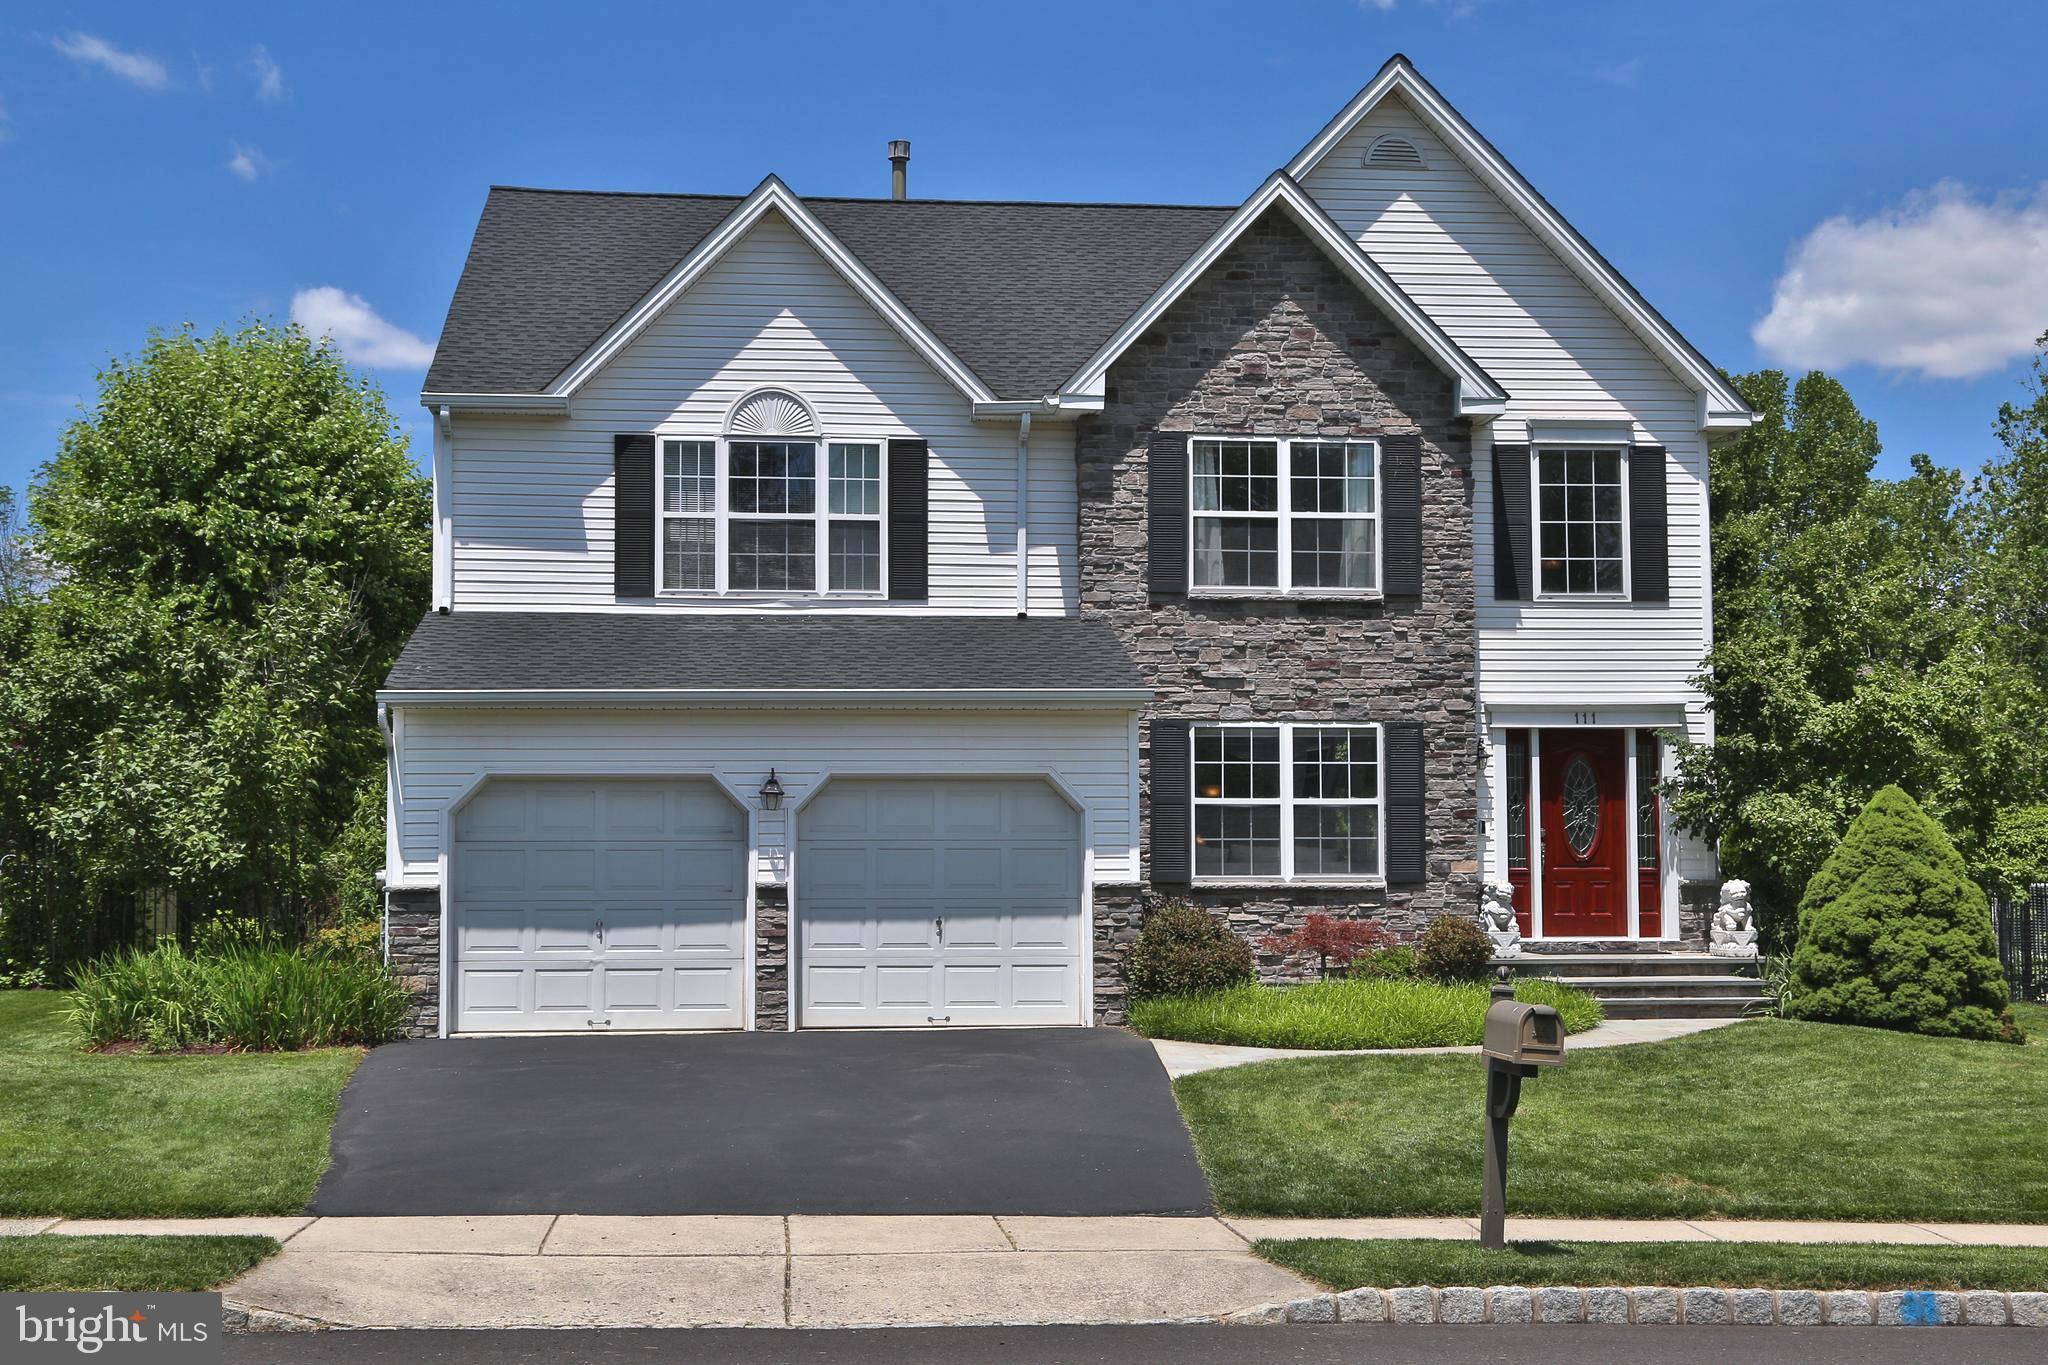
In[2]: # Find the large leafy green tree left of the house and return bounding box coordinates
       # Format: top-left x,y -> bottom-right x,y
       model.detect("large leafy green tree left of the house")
0,323 -> 430,960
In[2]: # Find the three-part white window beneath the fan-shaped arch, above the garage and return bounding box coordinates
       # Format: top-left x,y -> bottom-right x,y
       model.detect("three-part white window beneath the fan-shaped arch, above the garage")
659,438 -> 883,598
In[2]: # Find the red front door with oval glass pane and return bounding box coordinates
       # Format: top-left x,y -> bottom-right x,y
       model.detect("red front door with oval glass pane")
1538,731 -> 1632,939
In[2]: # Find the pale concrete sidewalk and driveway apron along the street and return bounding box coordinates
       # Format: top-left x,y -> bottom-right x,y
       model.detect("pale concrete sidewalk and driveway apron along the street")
16,1214 -> 2048,1328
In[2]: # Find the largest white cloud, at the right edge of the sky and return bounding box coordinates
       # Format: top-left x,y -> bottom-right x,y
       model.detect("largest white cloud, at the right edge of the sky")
1751,182 -> 2048,379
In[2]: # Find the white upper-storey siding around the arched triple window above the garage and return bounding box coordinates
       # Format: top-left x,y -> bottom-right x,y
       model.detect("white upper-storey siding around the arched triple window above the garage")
449,215 -> 1079,614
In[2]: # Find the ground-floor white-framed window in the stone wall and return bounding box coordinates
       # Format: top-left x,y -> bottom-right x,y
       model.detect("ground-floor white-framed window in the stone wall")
1192,724 -> 1382,882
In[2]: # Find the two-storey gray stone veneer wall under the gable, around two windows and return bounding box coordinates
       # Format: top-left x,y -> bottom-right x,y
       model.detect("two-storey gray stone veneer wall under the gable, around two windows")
1075,211 -> 1481,1023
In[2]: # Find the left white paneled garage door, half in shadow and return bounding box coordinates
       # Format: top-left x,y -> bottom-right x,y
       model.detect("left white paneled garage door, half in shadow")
449,780 -> 748,1033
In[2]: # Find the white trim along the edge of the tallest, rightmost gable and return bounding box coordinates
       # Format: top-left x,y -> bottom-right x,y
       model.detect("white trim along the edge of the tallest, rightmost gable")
1286,55 -> 1755,430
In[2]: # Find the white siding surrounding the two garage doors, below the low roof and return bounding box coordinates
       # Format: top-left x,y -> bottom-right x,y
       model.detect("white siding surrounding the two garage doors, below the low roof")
395,706 -> 1137,884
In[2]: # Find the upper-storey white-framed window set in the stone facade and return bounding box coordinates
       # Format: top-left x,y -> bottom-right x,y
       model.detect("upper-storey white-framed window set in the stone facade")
1188,436 -> 1380,593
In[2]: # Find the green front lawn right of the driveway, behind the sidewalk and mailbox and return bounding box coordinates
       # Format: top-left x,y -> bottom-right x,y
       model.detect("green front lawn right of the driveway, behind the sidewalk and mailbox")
1174,1019 -> 2048,1222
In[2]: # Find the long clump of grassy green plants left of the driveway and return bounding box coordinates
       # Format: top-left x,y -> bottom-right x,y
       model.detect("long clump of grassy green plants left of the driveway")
70,921 -> 406,1050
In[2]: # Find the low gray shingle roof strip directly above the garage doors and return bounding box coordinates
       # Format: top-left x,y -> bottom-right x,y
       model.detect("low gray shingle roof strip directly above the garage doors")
385,612 -> 1145,692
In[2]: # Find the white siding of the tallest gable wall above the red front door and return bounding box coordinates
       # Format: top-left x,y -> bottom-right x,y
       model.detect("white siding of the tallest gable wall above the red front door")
1305,96 -> 1712,739
